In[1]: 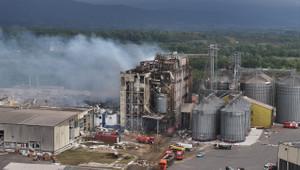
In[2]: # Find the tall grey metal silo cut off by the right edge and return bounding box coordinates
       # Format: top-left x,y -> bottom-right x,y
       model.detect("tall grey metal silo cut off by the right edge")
276,75 -> 300,123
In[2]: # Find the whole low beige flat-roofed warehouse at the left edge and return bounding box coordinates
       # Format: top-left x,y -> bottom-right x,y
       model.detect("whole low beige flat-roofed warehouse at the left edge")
0,108 -> 88,153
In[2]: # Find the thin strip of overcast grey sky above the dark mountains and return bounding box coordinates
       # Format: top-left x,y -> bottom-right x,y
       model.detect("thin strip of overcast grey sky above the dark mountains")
77,0 -> 300,10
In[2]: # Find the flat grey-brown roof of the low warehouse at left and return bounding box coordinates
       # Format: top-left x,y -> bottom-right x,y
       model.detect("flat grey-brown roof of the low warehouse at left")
0,108 -> 80,126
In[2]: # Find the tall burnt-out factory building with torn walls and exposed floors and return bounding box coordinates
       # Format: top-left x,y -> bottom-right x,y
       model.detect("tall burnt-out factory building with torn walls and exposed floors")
120,53 -> 192,133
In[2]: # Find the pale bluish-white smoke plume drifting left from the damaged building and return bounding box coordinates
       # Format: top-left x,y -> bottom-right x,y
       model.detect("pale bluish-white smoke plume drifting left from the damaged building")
0,30 -> 161,99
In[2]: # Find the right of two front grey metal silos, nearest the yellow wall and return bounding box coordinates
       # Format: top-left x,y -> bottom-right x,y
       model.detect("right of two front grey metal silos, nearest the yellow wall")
220,103 -> 247,142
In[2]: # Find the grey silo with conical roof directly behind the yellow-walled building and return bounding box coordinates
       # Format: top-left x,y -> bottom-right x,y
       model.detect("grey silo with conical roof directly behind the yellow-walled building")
241,73 -> 274,105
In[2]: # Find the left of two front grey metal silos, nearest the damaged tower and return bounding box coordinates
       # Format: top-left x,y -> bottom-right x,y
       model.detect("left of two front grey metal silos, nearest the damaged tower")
192,95 -> 224,141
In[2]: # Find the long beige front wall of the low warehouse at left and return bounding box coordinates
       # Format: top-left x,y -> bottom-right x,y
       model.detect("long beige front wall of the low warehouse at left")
0,124 -> 54,152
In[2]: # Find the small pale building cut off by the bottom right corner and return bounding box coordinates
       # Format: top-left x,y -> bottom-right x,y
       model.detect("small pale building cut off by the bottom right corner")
278,142 -> 300,170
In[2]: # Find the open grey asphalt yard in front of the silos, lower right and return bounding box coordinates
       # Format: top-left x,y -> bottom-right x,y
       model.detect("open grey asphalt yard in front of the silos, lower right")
170,127 -> 300,170
